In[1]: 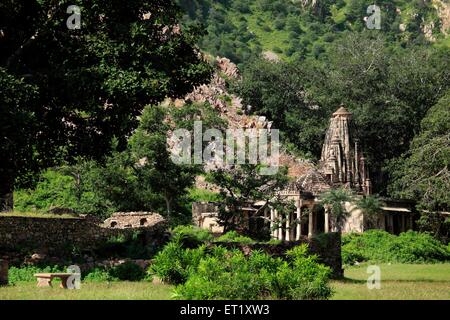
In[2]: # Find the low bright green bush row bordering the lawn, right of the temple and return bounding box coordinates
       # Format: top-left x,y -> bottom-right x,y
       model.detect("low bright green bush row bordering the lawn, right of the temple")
342,230 -> 450,264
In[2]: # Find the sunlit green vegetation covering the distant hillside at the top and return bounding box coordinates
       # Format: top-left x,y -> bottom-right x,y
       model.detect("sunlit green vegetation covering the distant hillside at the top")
178,0 -> 445,66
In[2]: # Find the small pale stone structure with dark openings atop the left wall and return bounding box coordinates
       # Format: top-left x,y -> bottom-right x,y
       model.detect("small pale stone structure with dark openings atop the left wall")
103,212 -> 164,229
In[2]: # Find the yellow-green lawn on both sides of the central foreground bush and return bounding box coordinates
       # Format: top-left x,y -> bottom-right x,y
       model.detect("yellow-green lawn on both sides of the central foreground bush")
0,263 -> 450,300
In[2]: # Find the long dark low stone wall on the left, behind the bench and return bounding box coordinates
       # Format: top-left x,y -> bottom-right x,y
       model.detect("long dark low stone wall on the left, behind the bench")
0,215 -> 166,256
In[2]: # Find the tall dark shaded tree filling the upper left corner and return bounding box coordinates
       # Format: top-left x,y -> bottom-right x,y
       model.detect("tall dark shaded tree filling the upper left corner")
0,0 -> 211,207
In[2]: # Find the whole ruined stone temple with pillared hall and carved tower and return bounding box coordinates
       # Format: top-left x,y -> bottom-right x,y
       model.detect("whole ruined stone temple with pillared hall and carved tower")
192,106 -> 415,241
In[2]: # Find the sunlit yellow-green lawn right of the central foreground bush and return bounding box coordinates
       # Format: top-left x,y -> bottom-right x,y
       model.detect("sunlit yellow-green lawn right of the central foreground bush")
332,263 -> 450,300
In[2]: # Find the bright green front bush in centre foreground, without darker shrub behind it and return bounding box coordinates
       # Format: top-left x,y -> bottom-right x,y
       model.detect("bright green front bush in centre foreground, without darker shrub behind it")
171,245 -> 332,300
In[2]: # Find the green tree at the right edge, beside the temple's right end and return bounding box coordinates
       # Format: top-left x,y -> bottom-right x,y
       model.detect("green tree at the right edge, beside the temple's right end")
389,92 -> 450,238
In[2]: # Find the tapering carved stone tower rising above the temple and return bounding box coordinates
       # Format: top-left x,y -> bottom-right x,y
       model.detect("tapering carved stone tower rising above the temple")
320,106 -> 372,194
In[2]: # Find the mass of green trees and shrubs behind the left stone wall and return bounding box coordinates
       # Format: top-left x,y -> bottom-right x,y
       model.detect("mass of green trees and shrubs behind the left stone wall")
15,104 -> 225,224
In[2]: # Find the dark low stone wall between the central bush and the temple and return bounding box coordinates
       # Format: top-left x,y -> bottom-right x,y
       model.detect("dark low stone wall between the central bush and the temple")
213,233 -> 344,278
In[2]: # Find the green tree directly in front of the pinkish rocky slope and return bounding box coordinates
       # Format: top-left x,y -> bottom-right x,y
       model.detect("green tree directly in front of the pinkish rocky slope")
130,104 -> 225,220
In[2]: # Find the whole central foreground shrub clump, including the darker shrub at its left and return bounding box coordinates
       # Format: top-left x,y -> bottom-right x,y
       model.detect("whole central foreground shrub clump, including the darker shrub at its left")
150,241 -> 332,299
